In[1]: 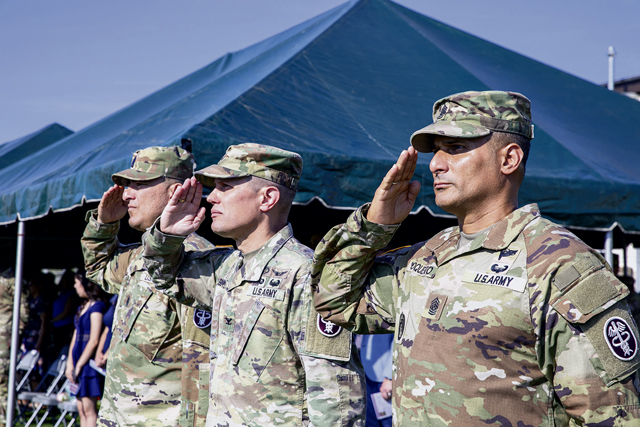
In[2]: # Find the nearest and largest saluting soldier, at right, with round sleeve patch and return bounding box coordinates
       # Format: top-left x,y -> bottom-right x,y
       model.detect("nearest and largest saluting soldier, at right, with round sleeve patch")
313,91 -> 640,426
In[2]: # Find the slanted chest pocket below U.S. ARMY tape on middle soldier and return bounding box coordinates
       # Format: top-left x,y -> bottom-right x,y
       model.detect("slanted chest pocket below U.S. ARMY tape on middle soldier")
231,300 -> 282,381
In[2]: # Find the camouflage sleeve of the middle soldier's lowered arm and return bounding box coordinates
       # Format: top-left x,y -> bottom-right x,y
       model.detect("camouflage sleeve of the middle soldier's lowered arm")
288,269 -> 366,427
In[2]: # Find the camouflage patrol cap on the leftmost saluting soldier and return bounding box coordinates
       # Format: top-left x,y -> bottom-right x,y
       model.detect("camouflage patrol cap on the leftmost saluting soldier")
111,146 -> 196,187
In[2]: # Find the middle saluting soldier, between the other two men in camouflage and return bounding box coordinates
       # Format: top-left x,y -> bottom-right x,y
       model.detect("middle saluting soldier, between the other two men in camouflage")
143,144 -> 366,427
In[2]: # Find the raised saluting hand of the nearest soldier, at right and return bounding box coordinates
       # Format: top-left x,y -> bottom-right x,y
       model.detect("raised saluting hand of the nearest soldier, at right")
367,147 -> 420,225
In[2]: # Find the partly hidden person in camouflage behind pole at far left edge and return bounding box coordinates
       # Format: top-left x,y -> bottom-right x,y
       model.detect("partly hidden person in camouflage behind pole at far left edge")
0,269 -> 29,424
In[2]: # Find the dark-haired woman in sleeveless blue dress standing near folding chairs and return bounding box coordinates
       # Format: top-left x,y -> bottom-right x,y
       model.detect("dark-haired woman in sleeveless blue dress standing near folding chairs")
66,273 -> 107,427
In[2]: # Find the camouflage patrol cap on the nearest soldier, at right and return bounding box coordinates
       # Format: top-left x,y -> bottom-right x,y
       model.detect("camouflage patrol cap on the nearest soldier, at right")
411,90 -> 533,153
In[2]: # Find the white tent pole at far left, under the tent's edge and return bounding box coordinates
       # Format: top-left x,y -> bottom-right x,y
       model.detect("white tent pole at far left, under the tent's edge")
6,220 -> 24,427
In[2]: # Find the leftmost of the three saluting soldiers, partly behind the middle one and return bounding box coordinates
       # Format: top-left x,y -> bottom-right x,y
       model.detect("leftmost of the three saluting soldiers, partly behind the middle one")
82,147 -> 213,427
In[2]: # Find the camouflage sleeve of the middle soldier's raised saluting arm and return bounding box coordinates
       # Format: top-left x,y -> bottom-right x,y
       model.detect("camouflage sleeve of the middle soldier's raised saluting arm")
142,221 -> 212,311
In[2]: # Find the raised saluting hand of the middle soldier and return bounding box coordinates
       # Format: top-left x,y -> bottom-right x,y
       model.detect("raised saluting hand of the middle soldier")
160,177 -> 205,236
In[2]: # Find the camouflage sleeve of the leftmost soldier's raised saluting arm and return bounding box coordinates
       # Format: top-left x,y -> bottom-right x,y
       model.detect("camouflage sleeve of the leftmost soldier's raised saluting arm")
80,209 -> 140,294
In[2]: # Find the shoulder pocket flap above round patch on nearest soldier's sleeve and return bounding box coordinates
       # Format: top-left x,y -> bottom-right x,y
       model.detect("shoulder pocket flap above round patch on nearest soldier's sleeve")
551,266 -> 628,323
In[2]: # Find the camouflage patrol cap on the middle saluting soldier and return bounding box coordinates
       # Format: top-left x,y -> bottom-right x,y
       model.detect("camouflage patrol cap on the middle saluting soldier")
196,143 -> 302,191
